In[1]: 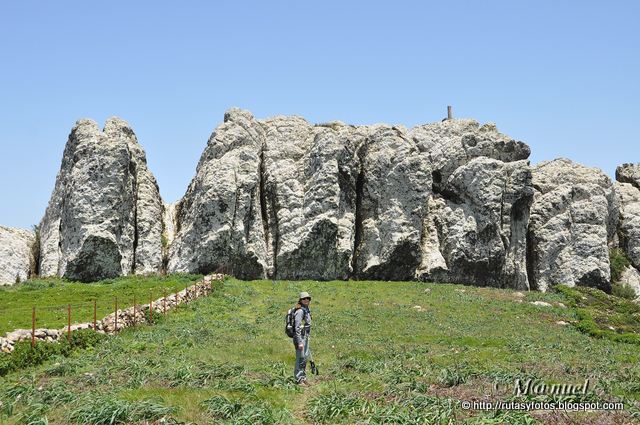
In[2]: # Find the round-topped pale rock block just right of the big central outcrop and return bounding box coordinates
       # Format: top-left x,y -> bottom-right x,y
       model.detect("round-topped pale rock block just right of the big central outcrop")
528,159 -> 618,290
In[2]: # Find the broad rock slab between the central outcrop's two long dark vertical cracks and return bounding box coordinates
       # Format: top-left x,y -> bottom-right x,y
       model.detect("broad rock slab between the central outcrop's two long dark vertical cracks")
262,117 -> 364,280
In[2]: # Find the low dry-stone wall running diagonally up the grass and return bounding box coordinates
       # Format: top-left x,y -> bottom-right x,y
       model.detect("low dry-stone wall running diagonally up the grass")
0,274 -> 224,353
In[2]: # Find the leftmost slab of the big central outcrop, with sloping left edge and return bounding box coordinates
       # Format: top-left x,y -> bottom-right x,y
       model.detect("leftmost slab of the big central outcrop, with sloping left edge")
168,110 -> 271,279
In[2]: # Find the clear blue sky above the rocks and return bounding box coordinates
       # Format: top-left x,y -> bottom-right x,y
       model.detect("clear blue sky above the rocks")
0,0 -> 640,227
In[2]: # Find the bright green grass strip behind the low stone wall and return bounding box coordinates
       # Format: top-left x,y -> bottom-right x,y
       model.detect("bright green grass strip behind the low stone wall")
0,274 -> 202,336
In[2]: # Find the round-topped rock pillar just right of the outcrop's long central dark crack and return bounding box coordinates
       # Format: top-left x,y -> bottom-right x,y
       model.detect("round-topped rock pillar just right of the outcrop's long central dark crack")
354,125 -> 432,280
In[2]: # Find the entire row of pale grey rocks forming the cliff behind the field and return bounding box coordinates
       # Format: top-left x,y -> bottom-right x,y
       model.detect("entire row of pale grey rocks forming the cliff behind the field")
0,109 -> 640,294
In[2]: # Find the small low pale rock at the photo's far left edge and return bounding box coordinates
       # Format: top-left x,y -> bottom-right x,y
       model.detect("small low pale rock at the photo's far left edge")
0,226 -> 35,285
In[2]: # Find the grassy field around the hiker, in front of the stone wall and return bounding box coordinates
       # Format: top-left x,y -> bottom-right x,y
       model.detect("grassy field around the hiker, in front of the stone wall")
0,279 -> 640,424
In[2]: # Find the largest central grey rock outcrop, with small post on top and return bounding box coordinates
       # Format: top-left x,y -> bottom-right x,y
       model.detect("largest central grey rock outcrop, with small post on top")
168,109 -> 532,288
